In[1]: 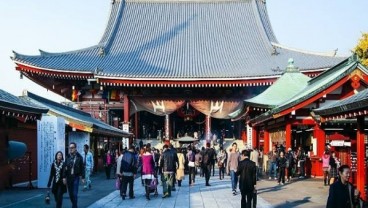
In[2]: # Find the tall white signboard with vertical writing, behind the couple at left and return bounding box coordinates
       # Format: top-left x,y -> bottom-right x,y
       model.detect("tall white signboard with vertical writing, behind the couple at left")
37,116 -> 65,188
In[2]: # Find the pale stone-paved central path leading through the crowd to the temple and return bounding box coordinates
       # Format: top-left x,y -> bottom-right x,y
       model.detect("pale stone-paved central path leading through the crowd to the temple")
89,175 -> 272,208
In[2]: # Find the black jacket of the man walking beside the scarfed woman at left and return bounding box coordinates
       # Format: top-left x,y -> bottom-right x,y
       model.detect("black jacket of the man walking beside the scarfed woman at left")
63,152 -> 86,179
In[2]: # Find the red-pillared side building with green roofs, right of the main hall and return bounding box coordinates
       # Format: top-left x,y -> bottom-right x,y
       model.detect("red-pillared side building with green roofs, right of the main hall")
242,55 -> 368,200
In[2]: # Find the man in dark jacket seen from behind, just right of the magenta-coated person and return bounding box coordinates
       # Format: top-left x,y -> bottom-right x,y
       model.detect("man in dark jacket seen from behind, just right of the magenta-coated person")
160,144 -> 179,198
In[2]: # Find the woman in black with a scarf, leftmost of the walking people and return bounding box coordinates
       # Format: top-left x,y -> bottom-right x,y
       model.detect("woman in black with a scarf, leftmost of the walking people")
47,151 -> 66,208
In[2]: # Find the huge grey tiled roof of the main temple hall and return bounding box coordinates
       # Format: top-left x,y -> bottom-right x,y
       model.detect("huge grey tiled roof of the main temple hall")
13,0 -> 344,80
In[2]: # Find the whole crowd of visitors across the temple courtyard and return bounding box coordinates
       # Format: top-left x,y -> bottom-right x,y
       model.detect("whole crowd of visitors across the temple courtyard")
47,142 -> 359,208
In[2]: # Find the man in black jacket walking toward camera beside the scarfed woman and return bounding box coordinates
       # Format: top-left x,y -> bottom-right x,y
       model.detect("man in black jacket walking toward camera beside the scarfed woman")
63,142 -> 86,208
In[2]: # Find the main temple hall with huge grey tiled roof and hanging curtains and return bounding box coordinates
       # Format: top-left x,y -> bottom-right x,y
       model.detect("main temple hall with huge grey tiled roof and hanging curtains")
12,0 -> 345,145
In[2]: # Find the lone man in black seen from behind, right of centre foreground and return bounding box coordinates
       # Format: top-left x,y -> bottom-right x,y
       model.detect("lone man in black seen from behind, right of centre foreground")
236,150 -> 257,208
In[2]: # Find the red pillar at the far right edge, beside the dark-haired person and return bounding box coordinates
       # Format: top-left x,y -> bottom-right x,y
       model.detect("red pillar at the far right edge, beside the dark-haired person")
357,116 -> 366,200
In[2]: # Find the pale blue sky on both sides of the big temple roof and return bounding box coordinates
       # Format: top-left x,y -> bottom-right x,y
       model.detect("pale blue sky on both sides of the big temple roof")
0,0 -> 368,101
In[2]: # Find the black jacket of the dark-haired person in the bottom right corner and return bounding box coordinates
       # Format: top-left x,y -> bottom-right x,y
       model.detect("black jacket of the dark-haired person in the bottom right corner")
326,179 -> 355,208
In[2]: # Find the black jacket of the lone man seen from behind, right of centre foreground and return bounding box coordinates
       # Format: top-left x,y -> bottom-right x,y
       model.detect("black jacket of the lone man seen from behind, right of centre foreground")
236,158 -> 257,194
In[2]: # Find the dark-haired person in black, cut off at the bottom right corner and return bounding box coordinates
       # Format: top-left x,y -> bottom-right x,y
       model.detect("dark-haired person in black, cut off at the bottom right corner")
326,165 -> 359,208
